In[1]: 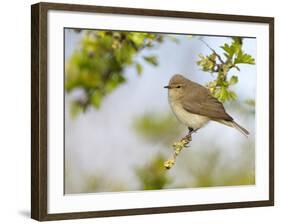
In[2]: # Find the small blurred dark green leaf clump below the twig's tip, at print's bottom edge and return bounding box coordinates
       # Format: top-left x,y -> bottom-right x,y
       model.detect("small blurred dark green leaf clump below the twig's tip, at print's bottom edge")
136,155 -> 171,190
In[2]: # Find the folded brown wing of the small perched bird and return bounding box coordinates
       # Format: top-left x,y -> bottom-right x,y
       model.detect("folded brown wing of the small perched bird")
182,85 -> 233,121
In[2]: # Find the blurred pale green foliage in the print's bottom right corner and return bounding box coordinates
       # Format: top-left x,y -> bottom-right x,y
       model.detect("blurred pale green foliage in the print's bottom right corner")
177,148 -> 255,187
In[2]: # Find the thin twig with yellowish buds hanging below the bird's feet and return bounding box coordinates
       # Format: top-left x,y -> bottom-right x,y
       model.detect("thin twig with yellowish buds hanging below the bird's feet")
164,132 -> 192,169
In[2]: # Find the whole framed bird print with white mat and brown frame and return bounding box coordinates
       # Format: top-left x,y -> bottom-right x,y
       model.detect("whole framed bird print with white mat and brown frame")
31,3 -> 274,221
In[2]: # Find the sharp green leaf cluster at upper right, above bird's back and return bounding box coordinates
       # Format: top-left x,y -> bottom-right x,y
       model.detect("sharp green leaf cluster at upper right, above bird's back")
197,37 -> 255,102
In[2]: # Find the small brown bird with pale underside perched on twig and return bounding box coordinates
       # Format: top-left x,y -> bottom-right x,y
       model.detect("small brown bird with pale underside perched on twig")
164,74 -> 249,136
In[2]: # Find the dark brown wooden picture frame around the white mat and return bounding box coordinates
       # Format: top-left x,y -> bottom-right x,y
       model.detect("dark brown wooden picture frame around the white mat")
31,3 -> 274,221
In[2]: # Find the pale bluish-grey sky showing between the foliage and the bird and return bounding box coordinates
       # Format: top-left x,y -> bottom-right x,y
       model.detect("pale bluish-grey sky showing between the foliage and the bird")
65,30 -> 256,194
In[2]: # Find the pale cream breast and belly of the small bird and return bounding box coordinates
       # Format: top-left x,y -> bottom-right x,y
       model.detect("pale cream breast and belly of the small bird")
170,101 -> 210,129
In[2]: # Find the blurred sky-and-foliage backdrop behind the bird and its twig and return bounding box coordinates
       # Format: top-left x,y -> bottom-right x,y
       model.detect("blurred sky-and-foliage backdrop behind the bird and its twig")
64,29 -> 256,194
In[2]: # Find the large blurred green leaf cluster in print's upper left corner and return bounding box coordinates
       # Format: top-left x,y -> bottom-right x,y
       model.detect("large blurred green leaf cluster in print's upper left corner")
65,31 -> 163,115
